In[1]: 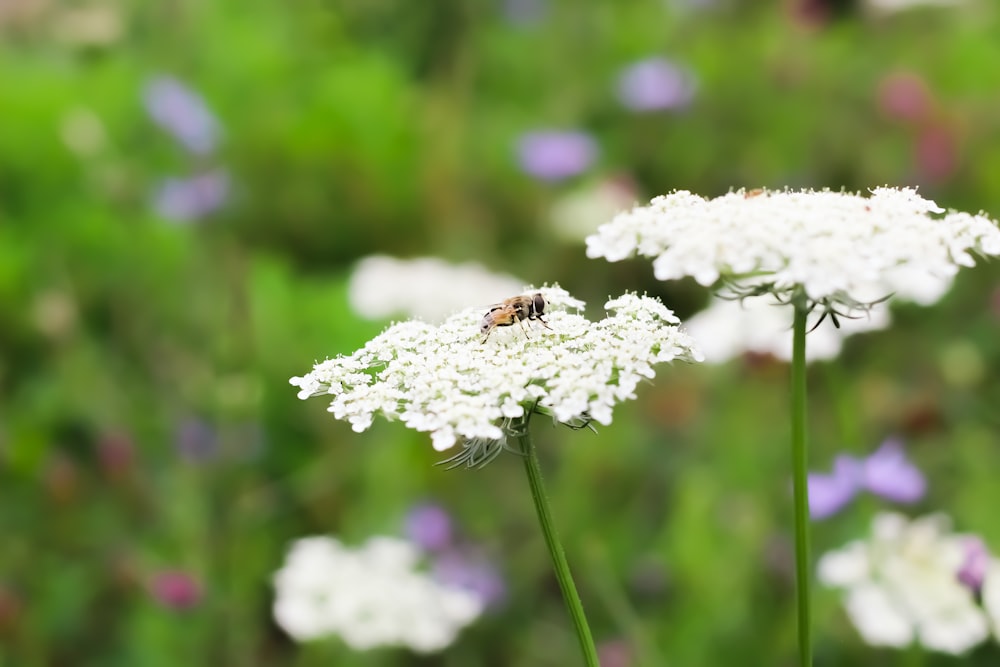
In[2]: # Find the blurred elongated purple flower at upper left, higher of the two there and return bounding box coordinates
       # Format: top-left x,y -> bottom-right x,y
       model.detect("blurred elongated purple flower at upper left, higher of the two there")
143,76 -> 219,155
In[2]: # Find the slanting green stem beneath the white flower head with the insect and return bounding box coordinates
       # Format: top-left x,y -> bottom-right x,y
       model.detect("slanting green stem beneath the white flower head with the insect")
517,417 -> 600,667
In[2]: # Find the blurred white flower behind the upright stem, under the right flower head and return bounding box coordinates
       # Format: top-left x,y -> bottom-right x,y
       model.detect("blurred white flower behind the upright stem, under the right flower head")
685,295 -> 890,364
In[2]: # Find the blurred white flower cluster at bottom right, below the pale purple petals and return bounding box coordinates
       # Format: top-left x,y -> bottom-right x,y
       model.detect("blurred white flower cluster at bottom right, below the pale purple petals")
818,513 -> 989,655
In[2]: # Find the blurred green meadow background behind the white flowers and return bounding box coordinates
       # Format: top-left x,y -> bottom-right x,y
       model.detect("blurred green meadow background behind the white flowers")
0,0 -> 1000,667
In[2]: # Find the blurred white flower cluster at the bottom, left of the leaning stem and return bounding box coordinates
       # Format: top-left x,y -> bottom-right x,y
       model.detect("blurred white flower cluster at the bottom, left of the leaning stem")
274,537 -> 483,653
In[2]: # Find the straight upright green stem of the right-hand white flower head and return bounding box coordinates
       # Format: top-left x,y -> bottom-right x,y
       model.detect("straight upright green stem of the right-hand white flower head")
791,295 -> 812,667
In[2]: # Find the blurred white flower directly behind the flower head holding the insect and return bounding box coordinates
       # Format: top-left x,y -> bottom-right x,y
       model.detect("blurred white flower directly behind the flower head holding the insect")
347,255 -> 524,322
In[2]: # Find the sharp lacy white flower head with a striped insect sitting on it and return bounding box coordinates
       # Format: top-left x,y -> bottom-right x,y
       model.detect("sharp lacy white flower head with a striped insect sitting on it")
291,287 -> 701,451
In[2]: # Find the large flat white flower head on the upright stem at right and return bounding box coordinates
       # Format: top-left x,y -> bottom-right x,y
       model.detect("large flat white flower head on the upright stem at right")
587,188 -> 1000,309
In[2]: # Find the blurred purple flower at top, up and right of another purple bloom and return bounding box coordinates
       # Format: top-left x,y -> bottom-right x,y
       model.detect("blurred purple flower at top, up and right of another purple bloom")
618,58 -> 695,112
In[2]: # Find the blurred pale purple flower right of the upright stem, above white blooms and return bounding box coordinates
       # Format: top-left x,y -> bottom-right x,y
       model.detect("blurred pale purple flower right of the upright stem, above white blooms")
809,438 -> 927,519
